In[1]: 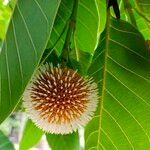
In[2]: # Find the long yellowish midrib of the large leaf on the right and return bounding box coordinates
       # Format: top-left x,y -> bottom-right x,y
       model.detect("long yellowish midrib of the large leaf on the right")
97,9 -> 110,149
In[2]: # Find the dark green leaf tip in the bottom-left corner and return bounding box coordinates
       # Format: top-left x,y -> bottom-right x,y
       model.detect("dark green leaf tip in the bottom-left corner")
0,131 -> 15,150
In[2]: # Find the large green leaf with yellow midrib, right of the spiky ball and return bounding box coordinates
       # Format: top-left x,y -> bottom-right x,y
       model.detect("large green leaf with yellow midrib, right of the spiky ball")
85,18 -> 150,150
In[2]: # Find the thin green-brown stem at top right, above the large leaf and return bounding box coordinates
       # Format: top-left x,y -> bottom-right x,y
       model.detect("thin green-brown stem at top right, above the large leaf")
123,0 -> 137,27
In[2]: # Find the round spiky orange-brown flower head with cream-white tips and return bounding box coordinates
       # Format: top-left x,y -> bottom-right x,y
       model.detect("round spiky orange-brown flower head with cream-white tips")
23,64 -> 98,134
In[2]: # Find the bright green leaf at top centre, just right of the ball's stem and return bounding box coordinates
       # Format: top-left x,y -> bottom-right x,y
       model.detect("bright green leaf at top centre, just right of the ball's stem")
75,0 -> 100,53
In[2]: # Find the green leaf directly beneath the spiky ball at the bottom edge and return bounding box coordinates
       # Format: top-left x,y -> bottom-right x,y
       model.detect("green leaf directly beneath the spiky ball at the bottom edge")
46,133 -> 80,150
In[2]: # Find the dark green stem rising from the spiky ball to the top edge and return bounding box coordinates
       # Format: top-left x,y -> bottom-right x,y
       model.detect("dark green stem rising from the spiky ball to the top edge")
61,0 -> 79,66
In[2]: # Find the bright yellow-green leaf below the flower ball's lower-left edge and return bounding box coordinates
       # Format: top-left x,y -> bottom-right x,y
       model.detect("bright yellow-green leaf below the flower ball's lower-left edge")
19,120 -> 43,150
